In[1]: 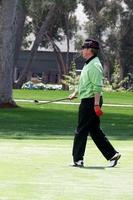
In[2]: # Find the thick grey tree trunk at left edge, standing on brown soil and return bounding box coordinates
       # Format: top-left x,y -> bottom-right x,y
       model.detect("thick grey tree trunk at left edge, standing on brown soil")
0,0 -> 18,108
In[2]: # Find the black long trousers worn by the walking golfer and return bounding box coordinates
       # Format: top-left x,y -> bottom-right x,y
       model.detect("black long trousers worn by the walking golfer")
72,97 -> 117,162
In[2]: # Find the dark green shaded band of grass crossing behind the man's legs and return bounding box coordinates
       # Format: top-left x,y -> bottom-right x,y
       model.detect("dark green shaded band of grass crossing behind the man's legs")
0,105 -> 133,140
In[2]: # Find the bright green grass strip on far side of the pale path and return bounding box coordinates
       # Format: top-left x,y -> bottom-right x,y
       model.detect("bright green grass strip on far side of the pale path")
13,90 -> 133,105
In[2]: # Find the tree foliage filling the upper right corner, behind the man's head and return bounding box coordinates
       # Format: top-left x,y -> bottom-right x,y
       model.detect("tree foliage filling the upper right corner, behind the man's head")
81,0 -> 133,79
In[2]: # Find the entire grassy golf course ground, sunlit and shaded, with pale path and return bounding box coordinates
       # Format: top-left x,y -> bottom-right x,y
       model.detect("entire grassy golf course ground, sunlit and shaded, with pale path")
0,90 -> 133,200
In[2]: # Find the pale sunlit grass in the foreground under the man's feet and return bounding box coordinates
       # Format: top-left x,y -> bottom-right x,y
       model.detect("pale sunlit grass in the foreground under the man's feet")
0,139 -> 133,200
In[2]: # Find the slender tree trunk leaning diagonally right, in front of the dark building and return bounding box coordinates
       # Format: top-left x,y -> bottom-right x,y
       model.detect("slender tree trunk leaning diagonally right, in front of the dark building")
15,5 -> 58,88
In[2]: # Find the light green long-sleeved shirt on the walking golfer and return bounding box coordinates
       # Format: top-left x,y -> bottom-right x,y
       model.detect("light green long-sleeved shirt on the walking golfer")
78,57 -> 103,99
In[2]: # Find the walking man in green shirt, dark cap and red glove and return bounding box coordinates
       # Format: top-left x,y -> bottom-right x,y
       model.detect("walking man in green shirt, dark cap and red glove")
69,39 -> 121,167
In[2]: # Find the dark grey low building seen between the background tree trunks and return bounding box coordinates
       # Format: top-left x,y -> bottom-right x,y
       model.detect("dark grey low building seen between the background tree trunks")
15,51 -> 83,83
